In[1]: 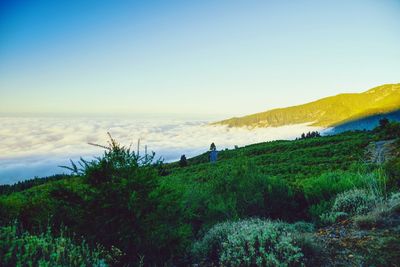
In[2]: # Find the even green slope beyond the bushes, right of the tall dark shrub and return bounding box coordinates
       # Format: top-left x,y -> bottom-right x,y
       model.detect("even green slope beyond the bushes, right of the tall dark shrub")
166,132 -> 372,180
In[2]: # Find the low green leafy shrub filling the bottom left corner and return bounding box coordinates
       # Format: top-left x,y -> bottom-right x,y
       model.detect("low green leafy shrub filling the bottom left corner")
0,226 -> 107,266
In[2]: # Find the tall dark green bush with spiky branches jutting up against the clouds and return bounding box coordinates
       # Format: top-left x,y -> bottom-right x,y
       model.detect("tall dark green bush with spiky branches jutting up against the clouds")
61,134 -> 161,264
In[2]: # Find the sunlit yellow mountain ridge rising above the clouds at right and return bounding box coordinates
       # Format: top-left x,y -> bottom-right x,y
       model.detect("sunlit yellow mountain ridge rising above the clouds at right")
213,84 -> 400,127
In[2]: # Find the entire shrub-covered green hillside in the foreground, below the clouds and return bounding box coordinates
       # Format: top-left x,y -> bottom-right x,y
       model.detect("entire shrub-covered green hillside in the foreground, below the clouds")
0,124 -> 400,266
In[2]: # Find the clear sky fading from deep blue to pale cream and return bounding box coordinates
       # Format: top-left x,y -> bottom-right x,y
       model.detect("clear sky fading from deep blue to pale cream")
0,0 -> 400,115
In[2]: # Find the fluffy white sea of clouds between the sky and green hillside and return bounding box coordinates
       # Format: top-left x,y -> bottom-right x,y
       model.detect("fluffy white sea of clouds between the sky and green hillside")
0,117 -> 321,184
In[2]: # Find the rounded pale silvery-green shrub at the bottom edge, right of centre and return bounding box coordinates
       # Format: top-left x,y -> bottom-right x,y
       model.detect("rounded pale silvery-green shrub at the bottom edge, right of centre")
192,219 -> 311,266
